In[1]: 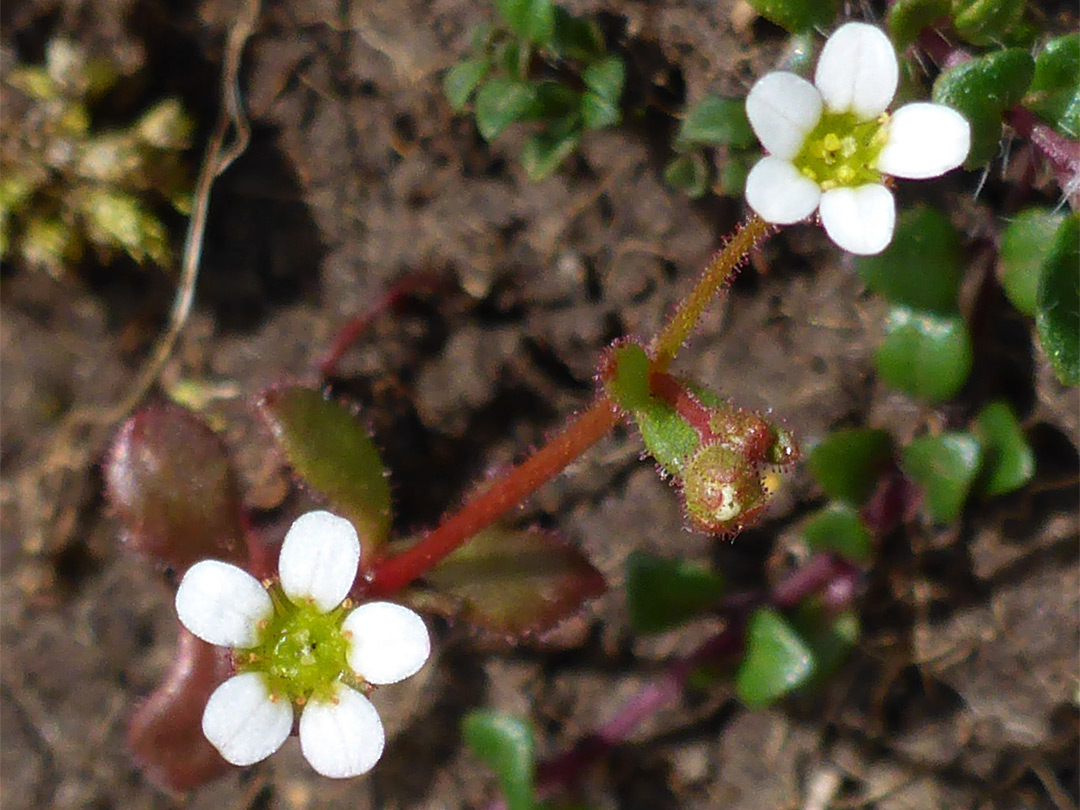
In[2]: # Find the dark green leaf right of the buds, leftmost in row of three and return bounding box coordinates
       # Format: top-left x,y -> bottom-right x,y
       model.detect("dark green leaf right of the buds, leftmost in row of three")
810,428 -> 892,505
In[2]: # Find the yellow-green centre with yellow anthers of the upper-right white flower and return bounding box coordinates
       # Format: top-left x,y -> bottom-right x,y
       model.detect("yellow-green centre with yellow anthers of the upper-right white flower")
792,111 -> 889,191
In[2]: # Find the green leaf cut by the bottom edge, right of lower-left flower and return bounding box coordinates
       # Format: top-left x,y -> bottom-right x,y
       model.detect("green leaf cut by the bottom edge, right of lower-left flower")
461,710 -> 536,810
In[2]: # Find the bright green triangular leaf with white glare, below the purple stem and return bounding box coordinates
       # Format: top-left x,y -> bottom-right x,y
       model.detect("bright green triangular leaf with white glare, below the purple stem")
735,607 -> 815,708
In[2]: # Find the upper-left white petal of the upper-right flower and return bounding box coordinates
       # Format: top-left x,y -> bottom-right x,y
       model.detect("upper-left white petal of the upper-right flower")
746,70 -> 822,158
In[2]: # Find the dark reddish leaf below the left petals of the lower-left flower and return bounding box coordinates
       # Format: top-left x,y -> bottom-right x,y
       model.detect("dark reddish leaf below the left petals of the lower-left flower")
127,627 -> 232,792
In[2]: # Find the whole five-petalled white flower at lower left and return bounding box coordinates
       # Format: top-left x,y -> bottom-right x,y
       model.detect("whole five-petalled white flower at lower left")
176,512 -> 431,778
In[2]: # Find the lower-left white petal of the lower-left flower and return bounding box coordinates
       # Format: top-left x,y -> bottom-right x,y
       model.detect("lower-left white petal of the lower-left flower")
203,672 -> 293,765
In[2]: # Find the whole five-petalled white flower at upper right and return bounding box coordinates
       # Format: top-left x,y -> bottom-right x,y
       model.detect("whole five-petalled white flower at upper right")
746,23 -> 971,255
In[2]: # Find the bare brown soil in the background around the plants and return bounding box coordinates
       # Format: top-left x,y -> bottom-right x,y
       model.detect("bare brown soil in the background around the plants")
0,0 -> 1080,810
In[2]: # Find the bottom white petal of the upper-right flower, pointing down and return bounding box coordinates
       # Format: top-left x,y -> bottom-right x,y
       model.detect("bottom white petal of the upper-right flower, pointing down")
821,184 -> 896,256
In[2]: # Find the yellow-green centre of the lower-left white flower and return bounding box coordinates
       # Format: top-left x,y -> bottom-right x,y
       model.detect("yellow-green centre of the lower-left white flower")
235,585 -> 352,704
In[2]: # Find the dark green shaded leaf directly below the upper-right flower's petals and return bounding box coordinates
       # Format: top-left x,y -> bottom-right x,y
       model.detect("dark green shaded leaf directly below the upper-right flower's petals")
855,205 -> 963,314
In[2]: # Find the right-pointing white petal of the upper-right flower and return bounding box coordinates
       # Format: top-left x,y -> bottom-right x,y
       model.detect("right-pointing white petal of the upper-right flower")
877,102 -> 971,180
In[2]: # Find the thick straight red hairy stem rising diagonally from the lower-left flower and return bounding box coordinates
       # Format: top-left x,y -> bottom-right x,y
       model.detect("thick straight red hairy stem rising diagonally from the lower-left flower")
361,394 -> 619,597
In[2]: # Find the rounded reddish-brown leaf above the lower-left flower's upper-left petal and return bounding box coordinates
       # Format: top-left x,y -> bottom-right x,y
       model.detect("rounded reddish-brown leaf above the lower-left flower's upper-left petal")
105,405 -> 244,572
